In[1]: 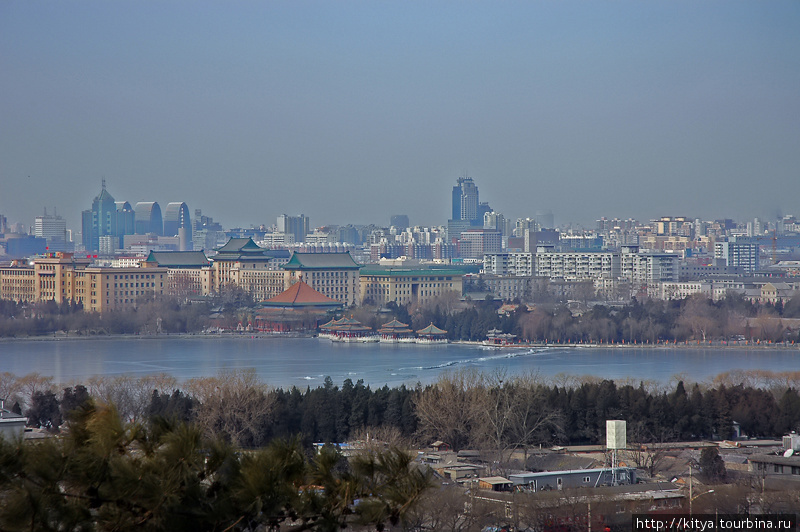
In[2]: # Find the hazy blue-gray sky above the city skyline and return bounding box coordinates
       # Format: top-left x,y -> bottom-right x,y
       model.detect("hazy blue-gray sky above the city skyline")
0,0 -> 800,228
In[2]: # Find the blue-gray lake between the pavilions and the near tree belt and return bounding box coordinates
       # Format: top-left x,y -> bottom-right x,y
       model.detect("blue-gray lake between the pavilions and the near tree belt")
0,336 -> 800,388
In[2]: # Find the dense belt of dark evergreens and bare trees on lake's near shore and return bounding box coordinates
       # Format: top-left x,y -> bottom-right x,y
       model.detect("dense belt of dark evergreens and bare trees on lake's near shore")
6,371 -> 800,454
